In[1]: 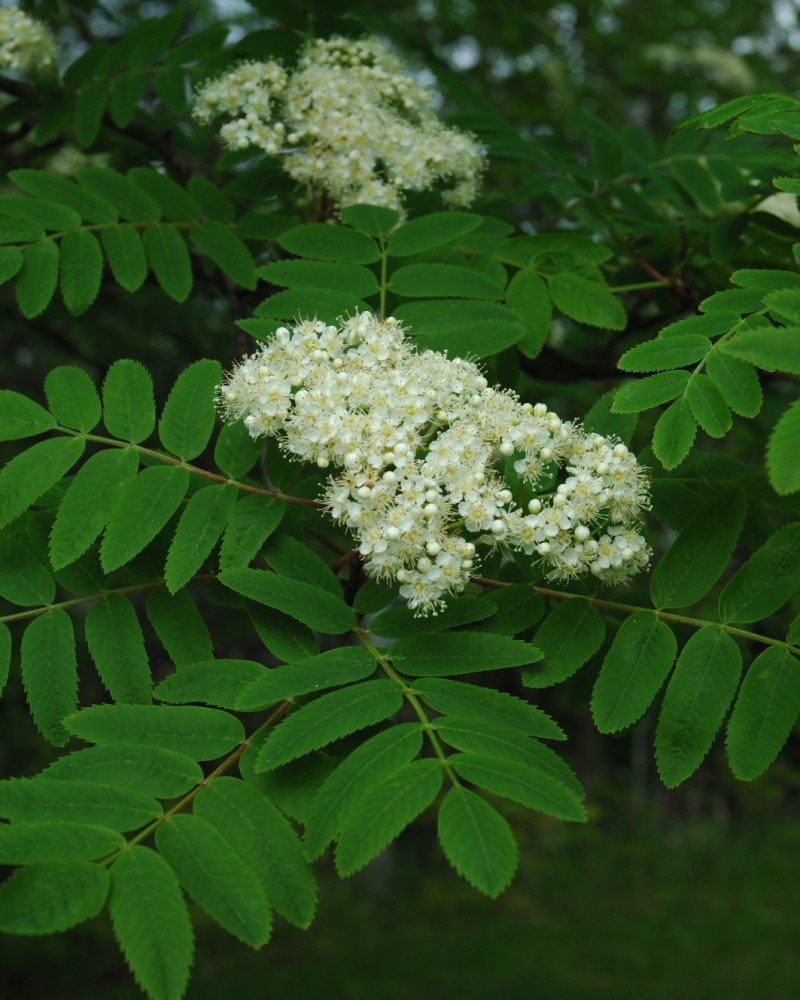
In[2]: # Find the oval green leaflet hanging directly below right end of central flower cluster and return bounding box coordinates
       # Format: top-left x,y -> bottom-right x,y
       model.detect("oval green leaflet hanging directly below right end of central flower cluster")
592,611 -> 677,733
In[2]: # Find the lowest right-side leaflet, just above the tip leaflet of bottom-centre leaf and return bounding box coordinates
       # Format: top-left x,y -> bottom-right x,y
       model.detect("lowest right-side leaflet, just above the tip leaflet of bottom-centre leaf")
448,753 -> 586,823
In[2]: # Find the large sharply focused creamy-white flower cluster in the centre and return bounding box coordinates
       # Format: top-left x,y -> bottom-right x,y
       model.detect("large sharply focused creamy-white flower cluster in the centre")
218,313 -> 651,614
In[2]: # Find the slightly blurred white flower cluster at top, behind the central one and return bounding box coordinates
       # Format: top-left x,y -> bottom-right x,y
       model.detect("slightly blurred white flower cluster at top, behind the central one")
193,36 -> 485,210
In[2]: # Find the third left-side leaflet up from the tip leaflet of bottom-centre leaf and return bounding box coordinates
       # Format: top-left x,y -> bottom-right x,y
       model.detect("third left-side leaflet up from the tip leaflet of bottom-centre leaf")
256,680 -> 403,771
